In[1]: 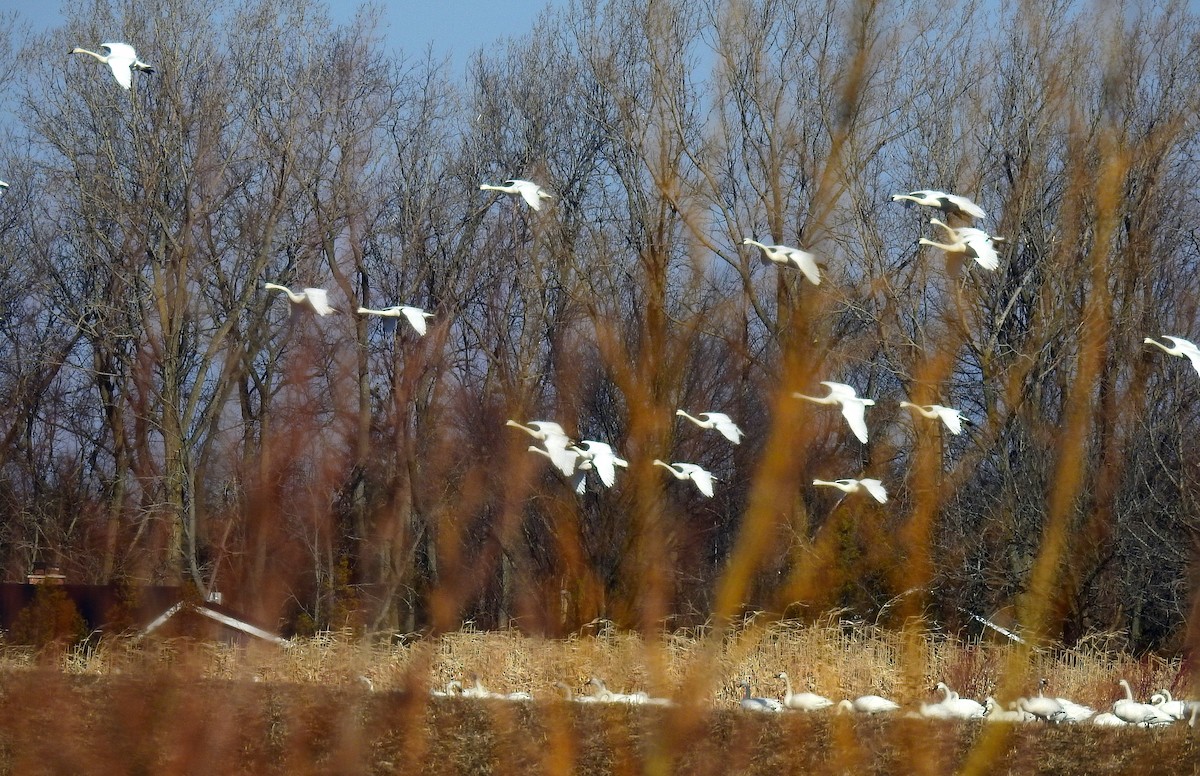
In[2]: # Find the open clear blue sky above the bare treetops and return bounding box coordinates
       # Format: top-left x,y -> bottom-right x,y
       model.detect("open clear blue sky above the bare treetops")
18,0 -> 556,67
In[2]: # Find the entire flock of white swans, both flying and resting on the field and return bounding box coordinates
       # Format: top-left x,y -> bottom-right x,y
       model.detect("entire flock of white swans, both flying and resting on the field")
51,42 -> 1200,727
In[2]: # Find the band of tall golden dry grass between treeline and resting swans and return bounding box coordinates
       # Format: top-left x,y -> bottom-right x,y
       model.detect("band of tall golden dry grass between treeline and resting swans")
16,619 -> 1192,708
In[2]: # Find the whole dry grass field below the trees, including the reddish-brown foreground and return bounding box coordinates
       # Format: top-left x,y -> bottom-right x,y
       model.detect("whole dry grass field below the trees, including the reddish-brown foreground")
0,622 -> 1200,774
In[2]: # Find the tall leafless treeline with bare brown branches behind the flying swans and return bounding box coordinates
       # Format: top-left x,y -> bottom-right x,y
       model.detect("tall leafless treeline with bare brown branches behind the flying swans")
0,0 -> 1200,646
